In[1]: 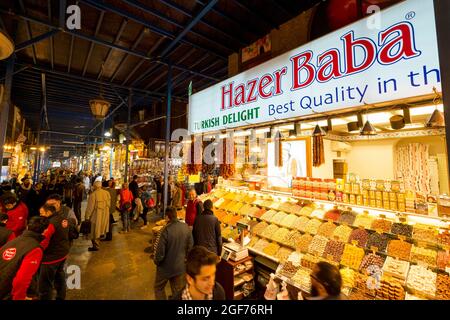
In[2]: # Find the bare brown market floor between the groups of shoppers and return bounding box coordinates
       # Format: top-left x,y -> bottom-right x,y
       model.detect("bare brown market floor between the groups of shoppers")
67,202 -> 165,300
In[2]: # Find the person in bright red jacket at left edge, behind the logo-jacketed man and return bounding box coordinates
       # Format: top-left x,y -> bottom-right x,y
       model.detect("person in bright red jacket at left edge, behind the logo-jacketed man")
1,193 -> 28,237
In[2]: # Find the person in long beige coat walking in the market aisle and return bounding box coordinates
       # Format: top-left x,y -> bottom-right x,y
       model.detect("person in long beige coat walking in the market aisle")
84,176 -> 111,251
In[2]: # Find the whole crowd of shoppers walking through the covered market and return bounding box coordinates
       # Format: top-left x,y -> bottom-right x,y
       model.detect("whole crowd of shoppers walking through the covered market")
0,172 -> 340,300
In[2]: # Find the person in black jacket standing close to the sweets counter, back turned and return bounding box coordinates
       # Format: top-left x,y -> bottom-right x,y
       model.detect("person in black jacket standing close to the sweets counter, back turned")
192,199 -> 222,256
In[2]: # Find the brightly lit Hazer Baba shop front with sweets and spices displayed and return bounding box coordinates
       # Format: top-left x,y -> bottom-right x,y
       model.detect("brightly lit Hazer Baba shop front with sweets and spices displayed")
188,0 -> 450,300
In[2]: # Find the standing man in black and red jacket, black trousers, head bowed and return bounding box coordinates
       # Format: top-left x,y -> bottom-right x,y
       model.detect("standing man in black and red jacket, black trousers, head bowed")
39,204 -> 70,300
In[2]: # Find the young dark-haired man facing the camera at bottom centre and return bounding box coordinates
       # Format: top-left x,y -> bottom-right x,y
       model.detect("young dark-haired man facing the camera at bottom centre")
173,246 -> 225,300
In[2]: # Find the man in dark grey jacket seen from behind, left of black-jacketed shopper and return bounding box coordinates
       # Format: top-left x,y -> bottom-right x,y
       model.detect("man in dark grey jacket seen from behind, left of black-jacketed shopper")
154,207 -> 193,300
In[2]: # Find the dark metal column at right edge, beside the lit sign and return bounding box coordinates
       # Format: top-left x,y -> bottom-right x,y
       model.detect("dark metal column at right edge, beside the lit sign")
434,0 -> 450,174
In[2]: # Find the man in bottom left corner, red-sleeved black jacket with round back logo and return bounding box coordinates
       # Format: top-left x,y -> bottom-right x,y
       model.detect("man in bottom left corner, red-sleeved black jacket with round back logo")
0,217 -> 48,300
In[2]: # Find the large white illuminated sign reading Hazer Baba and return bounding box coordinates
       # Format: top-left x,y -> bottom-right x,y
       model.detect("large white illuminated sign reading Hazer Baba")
189,0 -> 441,133
